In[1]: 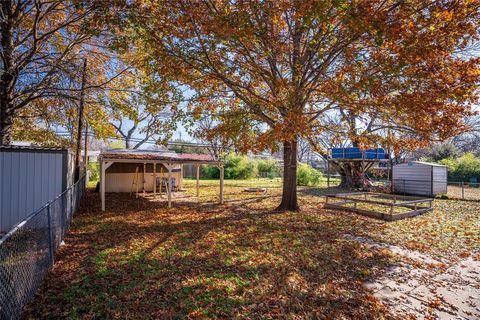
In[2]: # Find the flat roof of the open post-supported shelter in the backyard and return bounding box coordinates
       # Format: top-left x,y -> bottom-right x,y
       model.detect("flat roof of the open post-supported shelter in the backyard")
100,149 -> 222,163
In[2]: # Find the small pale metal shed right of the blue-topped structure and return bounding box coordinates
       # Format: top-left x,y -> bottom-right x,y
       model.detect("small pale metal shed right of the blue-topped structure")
392,161 -> 448,197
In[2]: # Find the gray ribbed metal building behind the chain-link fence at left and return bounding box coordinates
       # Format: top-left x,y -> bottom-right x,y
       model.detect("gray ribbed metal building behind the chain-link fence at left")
0,146 -> 74,233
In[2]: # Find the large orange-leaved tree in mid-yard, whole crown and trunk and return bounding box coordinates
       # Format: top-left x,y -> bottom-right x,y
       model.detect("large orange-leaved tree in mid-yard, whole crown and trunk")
118,0 -> 479,210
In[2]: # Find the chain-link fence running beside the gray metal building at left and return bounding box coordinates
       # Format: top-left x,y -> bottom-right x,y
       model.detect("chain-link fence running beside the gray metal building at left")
0,176 -> 85,320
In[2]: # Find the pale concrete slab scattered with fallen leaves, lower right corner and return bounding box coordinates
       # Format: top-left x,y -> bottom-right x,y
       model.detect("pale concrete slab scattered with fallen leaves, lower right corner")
345,235 -> 480,319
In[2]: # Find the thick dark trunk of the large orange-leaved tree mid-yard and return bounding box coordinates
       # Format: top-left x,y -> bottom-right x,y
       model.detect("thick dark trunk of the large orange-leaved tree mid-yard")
276,139 -> 299,211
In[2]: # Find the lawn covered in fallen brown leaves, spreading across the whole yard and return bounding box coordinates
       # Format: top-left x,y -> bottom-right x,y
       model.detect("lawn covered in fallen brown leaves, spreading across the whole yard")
26,181 -> 480,319
